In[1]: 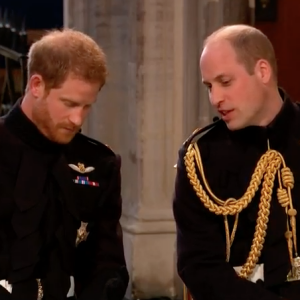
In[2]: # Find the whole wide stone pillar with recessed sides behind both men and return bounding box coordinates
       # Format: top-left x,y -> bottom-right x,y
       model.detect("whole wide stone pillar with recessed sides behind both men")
64,0 -> 253,299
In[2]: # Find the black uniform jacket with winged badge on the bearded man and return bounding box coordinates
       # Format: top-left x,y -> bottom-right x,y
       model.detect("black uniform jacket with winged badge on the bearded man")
0,102 -> 128,300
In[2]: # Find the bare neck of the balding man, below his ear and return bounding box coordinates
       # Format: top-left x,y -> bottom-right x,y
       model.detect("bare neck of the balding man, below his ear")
257,89 -> 283,126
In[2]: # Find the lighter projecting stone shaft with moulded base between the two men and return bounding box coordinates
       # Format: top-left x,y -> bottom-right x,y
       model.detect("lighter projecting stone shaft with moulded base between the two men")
122,0 -> 184,299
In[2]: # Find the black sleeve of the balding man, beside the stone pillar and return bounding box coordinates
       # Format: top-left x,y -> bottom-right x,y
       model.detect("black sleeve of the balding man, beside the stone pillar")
173,149 -> 281,300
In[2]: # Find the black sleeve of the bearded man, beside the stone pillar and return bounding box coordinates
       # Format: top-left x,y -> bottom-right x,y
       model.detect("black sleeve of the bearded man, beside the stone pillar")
78,156 -> 129,300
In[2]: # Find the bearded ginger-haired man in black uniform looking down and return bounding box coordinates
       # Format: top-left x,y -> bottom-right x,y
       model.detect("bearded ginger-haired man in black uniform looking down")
0,29 -> 128,300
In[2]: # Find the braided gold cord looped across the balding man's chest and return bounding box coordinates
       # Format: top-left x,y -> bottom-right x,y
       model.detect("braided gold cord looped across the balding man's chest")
184,141 -> 300,281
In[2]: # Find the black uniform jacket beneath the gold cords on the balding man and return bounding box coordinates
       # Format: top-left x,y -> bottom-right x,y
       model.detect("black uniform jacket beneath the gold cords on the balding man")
173,90 -> 300,300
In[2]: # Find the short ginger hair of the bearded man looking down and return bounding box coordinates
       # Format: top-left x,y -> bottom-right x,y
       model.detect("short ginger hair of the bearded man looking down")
27,29 -> 107,89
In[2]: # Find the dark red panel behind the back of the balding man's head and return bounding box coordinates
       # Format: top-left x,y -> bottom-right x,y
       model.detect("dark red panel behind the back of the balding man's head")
255,0 -> 300,101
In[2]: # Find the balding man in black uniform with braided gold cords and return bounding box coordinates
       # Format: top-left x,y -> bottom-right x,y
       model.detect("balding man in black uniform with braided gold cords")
173,25 -> 300,300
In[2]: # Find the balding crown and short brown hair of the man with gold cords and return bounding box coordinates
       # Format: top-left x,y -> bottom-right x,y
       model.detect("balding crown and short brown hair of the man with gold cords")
204,24 -> 277,80
